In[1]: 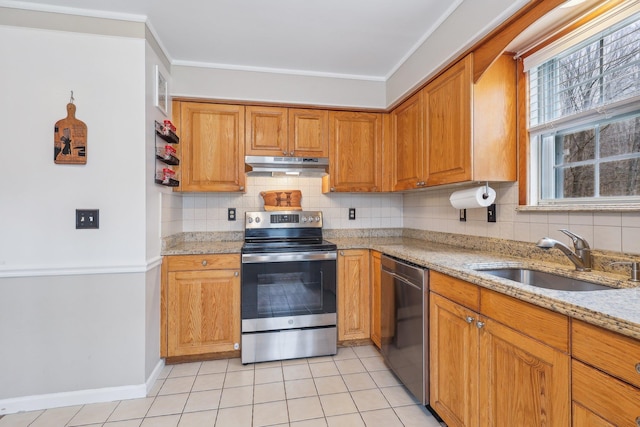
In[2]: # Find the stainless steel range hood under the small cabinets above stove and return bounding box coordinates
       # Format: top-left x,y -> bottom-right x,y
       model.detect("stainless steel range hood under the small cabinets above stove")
244,156 -> 329,176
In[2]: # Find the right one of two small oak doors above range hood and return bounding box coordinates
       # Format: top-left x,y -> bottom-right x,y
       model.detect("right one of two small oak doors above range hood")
289,108 -> 329,157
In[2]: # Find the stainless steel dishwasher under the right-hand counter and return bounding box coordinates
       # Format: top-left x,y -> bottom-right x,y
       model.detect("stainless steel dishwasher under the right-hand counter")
381,255 -> 429,405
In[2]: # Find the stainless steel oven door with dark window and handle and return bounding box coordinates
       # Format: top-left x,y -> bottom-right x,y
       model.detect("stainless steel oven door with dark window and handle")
241,251 -> 336,333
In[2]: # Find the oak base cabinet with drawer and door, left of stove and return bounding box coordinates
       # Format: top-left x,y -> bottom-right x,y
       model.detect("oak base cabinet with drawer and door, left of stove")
161,254 -> 240,357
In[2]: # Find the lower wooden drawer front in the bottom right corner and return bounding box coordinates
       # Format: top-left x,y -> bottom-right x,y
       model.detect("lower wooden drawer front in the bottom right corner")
571,360 -> 640,426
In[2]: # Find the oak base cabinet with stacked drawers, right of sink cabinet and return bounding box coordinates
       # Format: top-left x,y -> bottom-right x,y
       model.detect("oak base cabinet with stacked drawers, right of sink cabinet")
571,319 -> 640,427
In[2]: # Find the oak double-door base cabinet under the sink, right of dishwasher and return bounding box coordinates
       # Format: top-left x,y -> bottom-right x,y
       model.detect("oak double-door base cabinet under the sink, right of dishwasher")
430,271 -> 571,426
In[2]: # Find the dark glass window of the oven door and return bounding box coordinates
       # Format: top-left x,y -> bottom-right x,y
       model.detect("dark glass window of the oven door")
242,261 -> 336,319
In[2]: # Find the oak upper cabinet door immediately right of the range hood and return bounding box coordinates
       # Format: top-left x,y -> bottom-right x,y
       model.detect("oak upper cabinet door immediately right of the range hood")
323,111 -> 382,192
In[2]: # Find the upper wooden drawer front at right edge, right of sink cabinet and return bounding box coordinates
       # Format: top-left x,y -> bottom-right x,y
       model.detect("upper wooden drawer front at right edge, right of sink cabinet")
571,320 -> 640,388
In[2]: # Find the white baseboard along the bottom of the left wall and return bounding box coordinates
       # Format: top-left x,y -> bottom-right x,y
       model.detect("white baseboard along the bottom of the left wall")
0,359 -> 164,415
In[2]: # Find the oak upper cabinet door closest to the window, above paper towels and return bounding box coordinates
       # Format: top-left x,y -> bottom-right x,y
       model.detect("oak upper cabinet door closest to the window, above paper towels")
424,55 -> 473,185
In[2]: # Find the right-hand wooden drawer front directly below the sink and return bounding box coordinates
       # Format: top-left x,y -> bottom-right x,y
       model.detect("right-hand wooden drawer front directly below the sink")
480,289 -> 569,353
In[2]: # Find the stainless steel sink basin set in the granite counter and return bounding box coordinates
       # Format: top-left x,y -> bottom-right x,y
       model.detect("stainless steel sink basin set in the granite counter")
478,268 -> 616,291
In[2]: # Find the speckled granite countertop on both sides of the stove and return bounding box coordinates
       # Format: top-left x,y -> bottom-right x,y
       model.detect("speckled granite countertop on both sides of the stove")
163,236 -> 640,339
